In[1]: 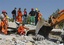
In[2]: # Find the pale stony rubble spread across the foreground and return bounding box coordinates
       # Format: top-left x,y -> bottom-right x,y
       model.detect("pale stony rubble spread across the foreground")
0,34 -> 61,45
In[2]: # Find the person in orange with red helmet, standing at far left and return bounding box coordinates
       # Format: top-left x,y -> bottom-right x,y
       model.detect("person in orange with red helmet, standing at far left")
1,10 -> 8,34
